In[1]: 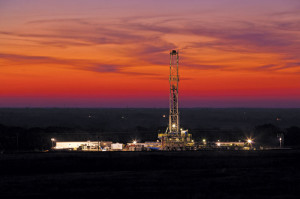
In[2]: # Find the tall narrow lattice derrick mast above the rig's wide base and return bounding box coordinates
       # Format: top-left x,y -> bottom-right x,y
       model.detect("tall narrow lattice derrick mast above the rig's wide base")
168,50 -> 180,136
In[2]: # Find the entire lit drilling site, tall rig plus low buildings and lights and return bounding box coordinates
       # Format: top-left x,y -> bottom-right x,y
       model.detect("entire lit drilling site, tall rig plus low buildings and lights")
51,50 -> 258,151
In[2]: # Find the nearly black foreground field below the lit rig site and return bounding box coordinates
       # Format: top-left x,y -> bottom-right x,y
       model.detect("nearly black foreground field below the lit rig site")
0,150 -> 300,199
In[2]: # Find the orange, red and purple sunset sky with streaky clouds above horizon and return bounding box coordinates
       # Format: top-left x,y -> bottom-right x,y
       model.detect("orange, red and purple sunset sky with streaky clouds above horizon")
0,0 -> 300,108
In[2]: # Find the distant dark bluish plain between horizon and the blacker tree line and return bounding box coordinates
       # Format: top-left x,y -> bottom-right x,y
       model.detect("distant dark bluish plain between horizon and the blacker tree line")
0,108 -> 300,131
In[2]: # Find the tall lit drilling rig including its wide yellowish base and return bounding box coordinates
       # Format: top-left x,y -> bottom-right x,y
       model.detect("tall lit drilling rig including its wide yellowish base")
158,50 -> 194,151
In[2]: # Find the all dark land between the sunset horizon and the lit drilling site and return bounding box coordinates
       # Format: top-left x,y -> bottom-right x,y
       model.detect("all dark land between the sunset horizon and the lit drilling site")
0,108 -> 300,150
